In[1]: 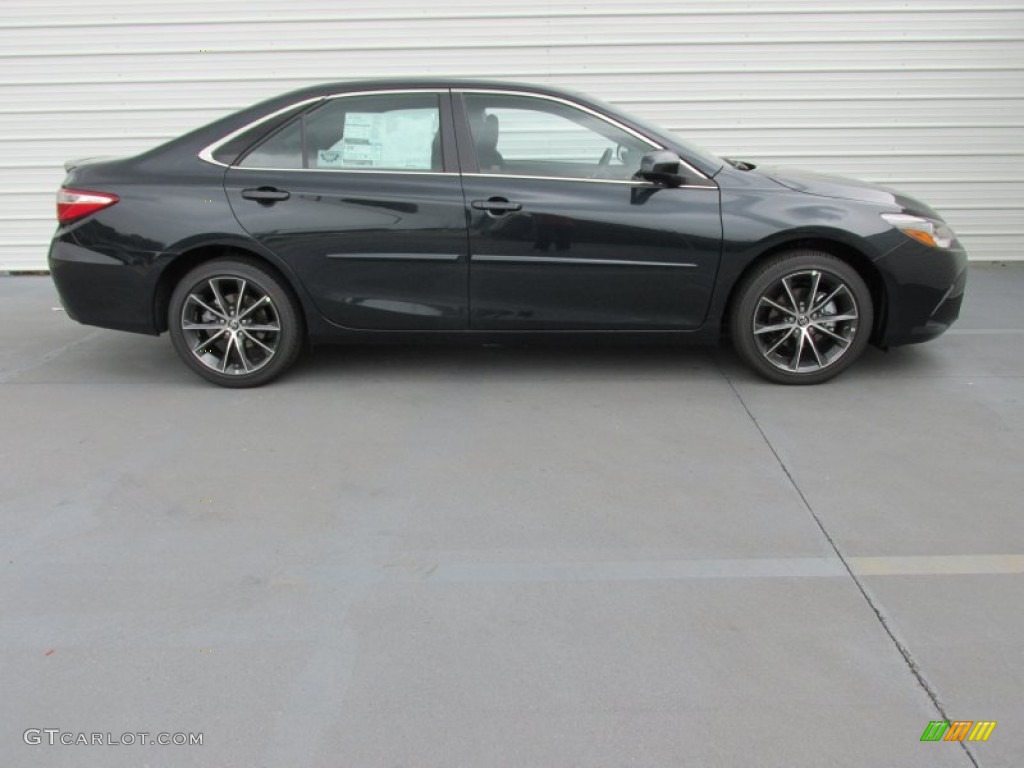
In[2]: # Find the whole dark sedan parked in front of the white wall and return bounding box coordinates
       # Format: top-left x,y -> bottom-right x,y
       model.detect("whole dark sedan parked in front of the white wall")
49,81 -> 967,387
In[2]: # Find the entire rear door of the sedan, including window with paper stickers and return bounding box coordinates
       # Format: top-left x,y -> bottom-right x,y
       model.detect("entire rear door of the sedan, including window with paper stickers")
225,90 -> 468,330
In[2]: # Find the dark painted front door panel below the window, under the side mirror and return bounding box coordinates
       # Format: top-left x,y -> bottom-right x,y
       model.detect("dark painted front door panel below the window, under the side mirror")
463,175 -> 722,331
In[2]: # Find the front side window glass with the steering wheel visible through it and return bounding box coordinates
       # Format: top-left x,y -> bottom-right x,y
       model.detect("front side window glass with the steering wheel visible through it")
465,93 -> 654,179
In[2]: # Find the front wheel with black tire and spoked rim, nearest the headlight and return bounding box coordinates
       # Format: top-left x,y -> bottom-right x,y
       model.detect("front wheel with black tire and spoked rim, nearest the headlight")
729,250 -> 874,384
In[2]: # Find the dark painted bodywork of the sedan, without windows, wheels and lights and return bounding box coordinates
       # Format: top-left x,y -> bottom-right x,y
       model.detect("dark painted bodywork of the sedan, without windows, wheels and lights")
49,81 -> 966,352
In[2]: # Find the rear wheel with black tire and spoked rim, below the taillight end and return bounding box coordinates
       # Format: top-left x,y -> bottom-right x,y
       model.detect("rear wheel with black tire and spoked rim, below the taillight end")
167,258 -> 305,388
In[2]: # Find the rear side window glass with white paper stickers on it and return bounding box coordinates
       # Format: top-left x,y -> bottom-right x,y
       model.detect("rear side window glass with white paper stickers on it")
240,93 -> 443,171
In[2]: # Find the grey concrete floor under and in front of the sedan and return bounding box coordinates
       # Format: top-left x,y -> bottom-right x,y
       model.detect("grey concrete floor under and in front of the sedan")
0,264 -> 1024,768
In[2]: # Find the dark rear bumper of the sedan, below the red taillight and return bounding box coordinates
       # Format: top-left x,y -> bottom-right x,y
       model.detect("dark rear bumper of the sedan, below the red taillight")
49,239 -> 160,336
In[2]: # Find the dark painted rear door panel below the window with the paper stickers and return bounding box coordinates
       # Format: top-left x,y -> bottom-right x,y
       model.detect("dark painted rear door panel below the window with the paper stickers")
224,169 -> 468,331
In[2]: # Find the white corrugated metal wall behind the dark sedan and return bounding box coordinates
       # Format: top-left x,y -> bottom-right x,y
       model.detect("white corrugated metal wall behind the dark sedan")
0,0 -> 1024,269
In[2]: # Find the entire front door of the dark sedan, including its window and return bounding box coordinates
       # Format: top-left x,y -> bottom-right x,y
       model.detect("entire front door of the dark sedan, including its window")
457,91 -> 722,330
